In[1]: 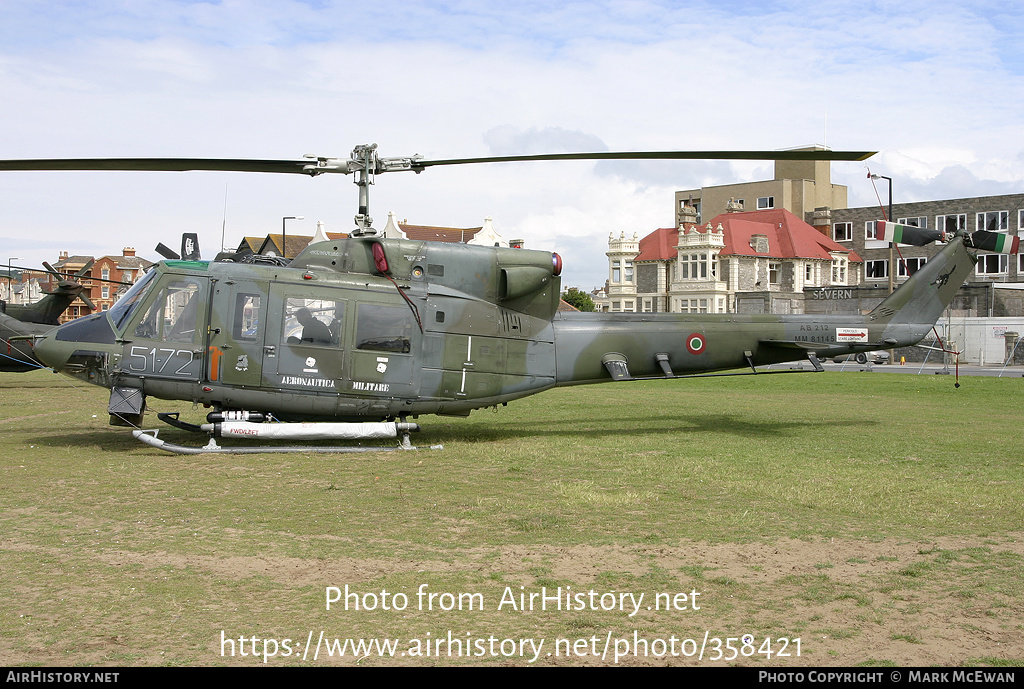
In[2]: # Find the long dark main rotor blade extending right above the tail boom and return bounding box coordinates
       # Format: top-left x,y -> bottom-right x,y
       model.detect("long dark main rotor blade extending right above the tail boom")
413,150 -> 878,170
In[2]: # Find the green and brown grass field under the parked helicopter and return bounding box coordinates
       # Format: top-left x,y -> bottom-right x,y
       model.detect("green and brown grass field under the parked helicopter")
0,372 -> 1024,668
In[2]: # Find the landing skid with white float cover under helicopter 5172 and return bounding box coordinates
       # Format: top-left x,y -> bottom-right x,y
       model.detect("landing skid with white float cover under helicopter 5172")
132,413 -> 442,455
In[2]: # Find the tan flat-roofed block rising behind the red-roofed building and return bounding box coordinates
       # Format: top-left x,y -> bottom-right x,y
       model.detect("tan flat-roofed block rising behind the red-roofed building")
675,145 -> 847,227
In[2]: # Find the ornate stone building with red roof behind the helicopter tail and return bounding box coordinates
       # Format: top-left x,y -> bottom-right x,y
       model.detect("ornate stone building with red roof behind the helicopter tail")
602,207 -> 861,313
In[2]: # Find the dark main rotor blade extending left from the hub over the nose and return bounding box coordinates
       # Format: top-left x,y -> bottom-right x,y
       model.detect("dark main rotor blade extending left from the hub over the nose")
0,158 -> 316,174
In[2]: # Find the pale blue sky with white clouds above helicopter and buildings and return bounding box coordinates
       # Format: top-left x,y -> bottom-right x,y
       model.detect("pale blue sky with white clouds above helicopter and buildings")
0,0 -> 1024,290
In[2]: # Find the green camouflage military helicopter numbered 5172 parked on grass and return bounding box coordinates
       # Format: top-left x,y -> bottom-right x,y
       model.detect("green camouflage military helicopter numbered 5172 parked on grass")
0,144 -> 1016,453
